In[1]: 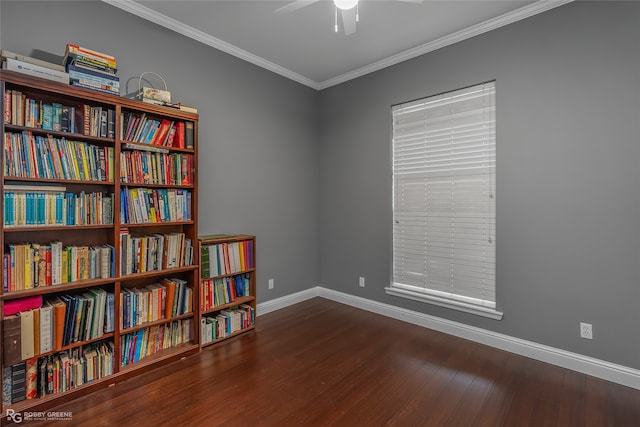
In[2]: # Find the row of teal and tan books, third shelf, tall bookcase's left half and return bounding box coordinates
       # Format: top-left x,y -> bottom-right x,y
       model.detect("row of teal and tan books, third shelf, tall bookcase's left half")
3,185 -> 113,227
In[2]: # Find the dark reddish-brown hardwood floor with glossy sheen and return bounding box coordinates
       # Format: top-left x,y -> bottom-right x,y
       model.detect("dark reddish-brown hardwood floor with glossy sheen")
17,298 -> 640,427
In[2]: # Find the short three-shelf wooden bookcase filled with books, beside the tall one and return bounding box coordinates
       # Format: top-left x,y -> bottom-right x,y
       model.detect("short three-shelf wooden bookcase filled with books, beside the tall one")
198,234 -> 256,347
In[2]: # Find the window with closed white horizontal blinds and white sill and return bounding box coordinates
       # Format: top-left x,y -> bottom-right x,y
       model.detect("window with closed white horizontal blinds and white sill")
386,82 -> 502,319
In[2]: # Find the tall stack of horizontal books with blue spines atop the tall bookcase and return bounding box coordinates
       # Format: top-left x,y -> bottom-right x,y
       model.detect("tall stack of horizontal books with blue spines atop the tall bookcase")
64,43 -> 120,95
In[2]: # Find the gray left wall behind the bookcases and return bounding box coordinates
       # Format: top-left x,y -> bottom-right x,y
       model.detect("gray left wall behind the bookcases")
0,0 -> 319,302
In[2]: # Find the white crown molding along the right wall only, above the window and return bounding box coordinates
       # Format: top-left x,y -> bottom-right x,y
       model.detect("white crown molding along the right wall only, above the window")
318,0 -> 574,90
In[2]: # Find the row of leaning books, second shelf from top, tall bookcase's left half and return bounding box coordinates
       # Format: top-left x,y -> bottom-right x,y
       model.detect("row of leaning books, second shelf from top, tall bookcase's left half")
4,131 -> 114,182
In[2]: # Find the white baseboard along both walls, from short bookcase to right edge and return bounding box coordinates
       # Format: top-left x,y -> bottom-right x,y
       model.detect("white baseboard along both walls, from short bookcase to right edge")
257,286 -> 640,390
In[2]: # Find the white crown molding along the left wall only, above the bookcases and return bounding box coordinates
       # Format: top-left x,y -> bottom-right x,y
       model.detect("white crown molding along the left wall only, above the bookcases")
102,0 -> 320,90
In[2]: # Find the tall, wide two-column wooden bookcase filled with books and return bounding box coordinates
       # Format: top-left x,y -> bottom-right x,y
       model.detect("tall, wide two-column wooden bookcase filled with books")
0,70 -> 200,421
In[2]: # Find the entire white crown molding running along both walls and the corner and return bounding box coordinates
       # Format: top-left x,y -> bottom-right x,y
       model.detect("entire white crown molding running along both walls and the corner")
102,0 -> 574,90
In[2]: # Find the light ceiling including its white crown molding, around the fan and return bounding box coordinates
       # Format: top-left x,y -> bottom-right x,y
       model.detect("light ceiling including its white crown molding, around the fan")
103,0 -> 571,90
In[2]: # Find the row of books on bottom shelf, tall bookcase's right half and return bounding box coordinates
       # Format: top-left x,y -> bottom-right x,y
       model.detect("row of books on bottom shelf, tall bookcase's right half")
120,319 -> 192,366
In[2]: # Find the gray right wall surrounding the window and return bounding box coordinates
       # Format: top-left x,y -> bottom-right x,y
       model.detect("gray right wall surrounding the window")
320,1 -> 640,368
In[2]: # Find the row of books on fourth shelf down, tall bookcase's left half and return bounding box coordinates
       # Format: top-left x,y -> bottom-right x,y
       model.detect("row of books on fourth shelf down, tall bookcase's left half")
2,241 -> 115,292
